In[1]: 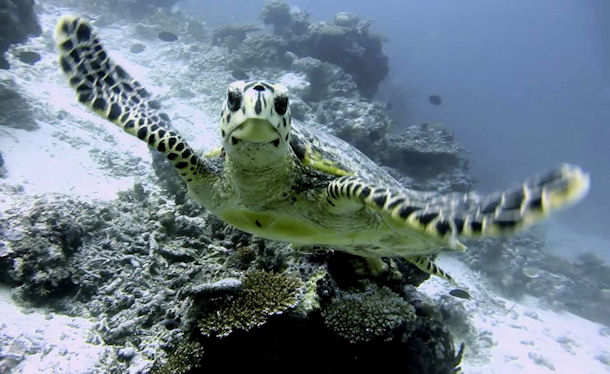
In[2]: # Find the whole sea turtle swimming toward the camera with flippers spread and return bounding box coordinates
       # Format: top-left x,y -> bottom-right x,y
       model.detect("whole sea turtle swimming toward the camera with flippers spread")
55,16 -> 589,280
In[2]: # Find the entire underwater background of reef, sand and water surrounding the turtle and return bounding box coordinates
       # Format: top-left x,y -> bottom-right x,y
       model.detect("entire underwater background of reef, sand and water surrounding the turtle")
0,0 -> 610,373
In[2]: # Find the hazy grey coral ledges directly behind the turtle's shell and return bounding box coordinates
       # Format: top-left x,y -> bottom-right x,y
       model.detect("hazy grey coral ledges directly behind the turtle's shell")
308,100 -> 472,192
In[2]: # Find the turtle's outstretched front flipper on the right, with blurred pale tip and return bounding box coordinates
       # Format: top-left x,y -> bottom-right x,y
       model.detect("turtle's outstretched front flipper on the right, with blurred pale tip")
327,164 -> 589,243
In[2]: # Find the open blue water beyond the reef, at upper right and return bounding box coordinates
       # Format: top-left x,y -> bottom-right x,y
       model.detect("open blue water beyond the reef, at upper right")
183,0 -> 610,260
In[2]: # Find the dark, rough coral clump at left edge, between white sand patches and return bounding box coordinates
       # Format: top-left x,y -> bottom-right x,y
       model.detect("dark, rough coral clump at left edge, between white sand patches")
0,190 -> 88,304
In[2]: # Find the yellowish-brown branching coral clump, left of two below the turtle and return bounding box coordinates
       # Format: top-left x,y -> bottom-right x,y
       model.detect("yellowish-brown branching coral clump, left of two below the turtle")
199,270 -> 302,337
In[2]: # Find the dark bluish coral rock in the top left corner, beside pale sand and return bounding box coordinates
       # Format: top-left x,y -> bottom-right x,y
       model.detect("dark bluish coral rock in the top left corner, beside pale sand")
0,0 -> 42,69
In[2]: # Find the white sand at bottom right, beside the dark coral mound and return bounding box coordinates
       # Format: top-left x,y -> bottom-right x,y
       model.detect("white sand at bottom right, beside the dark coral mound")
419,254 -> 610,374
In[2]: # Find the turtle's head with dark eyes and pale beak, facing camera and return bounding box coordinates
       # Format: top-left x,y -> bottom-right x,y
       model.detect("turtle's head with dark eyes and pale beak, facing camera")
220,81 -> 291,167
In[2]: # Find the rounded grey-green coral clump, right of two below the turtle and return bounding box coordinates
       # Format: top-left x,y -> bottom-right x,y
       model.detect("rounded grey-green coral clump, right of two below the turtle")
322,286 -> 416,343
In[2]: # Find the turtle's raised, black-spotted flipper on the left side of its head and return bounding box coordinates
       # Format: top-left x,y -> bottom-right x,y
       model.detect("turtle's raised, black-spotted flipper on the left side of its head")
55,16 -> 209,182
